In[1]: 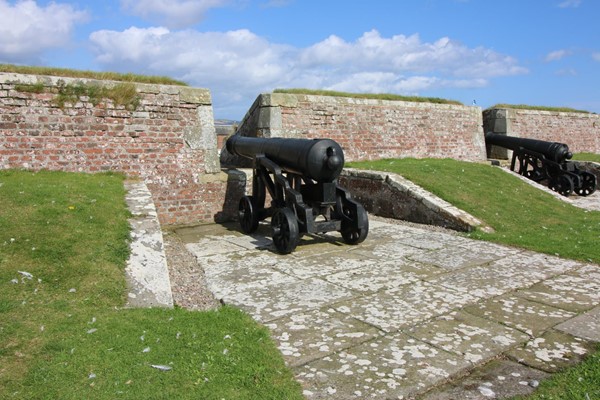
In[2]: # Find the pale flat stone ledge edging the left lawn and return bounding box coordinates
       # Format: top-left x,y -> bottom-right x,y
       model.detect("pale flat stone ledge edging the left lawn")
125,181 -> 173,307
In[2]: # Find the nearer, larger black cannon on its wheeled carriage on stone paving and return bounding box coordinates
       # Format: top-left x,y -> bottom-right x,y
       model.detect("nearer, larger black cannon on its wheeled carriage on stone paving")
226,135 -> 369,254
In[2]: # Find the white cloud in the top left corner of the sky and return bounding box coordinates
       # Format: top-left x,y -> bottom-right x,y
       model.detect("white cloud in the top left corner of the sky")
0,0 -> 88,63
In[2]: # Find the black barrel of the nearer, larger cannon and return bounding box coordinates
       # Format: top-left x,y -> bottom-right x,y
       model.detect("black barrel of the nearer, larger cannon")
226,135 -> 344,182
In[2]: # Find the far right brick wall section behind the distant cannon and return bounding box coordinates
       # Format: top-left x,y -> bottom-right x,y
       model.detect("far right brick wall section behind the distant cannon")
483,108 -> 600,158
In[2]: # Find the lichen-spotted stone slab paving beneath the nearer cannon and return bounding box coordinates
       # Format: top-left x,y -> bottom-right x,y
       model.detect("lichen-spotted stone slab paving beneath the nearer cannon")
177,217 -> 600,400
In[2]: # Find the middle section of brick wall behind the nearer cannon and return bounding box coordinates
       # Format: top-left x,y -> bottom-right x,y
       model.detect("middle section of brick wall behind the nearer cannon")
231,93 -> 485,161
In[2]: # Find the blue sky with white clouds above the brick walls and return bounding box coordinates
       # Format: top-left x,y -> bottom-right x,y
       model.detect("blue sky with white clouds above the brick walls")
0,0 -> 600,120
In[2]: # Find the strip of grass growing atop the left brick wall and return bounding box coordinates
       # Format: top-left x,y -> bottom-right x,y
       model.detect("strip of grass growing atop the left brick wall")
0,64 -> 187,86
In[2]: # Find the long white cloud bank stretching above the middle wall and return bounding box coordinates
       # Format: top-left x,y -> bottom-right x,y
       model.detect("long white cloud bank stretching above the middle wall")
90,28 -> 527,118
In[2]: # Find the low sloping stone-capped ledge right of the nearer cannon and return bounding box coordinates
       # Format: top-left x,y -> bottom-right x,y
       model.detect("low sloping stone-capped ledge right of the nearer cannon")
340,168 -> 493,232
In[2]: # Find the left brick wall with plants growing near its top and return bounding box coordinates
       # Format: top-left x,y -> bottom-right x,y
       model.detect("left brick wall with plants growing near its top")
0,73 -> 243,225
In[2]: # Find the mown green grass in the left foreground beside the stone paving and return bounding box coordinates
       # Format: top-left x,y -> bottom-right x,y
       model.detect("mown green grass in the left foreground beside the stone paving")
0,171 -> 302,399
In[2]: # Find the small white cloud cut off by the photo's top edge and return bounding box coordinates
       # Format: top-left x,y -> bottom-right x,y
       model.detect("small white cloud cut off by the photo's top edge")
121,0 -> 231,28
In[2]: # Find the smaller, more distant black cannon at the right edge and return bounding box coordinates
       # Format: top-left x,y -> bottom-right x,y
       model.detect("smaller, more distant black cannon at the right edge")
485,132 -> 596,196
